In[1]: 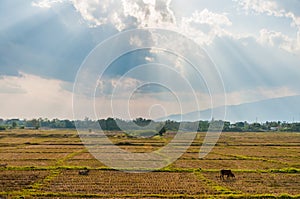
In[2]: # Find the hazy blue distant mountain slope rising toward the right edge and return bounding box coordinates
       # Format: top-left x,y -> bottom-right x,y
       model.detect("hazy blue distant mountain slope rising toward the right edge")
158,95 -> 300,122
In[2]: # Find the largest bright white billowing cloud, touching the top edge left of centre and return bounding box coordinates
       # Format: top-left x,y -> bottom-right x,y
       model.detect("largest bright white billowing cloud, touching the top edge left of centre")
32,0 -> 175,31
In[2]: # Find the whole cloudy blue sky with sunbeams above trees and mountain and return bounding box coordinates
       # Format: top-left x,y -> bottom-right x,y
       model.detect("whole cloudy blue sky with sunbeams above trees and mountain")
0,0 -> 300,119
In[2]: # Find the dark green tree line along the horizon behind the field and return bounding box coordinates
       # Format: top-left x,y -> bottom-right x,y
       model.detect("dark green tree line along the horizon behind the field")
0,118 -> 300,132
